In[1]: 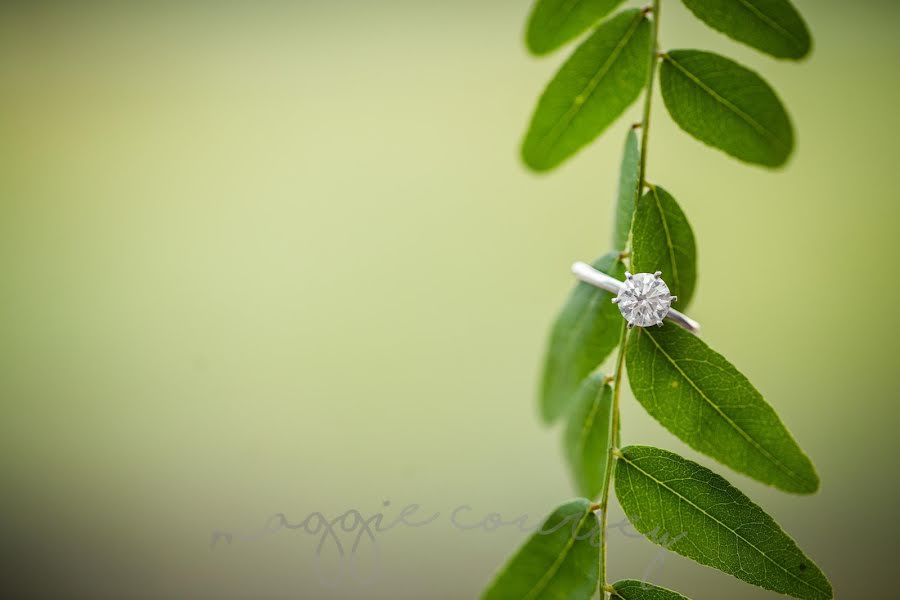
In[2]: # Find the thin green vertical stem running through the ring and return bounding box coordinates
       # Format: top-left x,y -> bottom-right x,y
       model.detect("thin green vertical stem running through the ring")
600,0 -> 660,600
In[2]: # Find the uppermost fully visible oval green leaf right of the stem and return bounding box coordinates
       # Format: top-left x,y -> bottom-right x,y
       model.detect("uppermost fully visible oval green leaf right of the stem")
659,50 -> 794,167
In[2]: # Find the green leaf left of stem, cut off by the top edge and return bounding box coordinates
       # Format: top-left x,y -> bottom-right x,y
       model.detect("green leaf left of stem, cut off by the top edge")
525,0 -> 622,55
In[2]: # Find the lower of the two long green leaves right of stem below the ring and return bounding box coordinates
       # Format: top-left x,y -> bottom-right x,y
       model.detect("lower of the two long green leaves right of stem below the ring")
615,446 -> 832,600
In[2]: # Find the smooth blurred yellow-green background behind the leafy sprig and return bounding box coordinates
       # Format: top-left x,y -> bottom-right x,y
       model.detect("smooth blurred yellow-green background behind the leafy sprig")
0,0 -> 900,599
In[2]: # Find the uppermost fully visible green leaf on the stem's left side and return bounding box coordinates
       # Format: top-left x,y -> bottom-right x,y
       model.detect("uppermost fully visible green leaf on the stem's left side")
522,9 -> 650,171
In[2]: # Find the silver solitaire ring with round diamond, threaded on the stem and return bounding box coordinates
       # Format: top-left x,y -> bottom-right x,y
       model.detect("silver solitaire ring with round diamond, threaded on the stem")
572,262 -> 700,333
